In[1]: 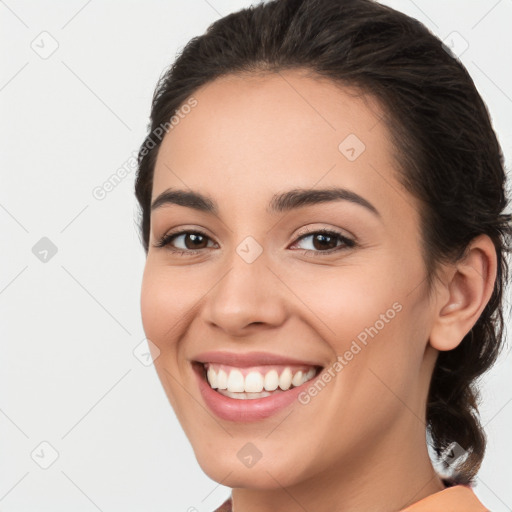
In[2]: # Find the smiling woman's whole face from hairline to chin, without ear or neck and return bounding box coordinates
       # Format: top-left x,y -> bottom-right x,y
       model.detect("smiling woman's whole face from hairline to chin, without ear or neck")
141,71 -> 436,488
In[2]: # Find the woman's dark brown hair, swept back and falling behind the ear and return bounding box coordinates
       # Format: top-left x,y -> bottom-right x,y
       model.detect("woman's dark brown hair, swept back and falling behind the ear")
135,0 -> 512,483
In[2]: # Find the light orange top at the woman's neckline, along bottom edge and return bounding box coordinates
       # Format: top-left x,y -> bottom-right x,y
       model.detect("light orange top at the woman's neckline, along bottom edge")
215,485 -> 490,512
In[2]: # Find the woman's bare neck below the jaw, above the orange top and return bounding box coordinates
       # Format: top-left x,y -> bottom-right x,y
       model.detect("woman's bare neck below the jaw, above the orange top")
232,415 -> 445,512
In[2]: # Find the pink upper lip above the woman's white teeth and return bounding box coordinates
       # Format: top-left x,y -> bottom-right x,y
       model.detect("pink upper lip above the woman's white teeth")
192,351 -> 322,368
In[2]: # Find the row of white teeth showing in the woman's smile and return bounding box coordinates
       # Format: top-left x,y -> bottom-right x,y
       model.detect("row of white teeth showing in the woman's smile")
206,365 -> 316,399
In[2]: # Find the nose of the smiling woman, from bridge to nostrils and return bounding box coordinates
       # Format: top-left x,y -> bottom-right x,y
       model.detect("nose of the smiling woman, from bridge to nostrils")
202,247 -> 287,337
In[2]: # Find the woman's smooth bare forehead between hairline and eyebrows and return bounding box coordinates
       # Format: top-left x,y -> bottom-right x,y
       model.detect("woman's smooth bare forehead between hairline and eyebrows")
153,70 -> 412,218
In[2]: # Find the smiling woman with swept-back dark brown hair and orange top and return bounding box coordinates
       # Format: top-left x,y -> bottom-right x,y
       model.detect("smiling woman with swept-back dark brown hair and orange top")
136,0 -> 511,512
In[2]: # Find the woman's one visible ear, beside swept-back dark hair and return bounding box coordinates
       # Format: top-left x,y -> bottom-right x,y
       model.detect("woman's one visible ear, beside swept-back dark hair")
430,235 -> 497,350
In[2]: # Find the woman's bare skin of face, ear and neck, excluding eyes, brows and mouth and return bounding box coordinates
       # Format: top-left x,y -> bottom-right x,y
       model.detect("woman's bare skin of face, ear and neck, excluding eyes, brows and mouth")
141,70 -> 496,512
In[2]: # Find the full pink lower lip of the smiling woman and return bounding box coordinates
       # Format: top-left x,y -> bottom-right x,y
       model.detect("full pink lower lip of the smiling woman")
193,364 -> 316,423
